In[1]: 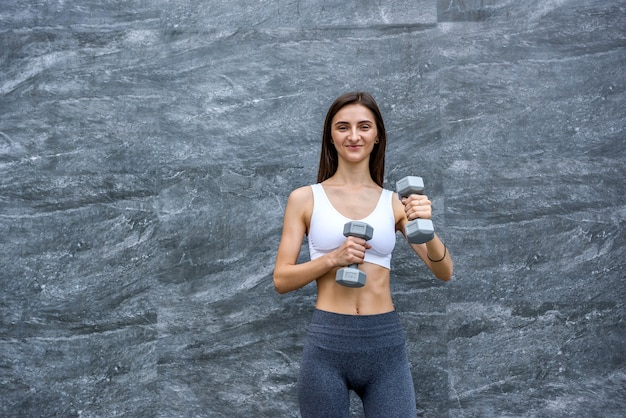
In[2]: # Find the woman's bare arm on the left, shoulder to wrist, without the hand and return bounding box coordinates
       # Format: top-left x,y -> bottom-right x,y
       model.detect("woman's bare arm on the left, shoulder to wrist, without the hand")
274,187 -> 336,294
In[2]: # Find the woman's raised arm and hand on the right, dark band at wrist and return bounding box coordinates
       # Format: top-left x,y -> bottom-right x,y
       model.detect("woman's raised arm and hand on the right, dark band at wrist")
394,194 -> 454,281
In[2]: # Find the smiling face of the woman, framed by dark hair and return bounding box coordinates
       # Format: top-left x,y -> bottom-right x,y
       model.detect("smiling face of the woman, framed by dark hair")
331,104 -> 378,162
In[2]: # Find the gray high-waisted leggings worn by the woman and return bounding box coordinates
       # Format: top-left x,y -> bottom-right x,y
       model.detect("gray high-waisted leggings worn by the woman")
298,309 -> 417,418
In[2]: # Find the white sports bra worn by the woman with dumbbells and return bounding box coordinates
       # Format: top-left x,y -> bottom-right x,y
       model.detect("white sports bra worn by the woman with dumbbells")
308,183 -> 396,269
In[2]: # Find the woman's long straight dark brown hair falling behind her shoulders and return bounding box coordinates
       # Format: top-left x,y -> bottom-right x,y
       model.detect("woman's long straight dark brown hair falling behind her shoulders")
317,92 -> 387,187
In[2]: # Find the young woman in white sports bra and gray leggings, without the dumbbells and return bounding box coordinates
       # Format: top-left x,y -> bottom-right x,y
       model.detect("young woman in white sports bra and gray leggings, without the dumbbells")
274,92 -> 452,418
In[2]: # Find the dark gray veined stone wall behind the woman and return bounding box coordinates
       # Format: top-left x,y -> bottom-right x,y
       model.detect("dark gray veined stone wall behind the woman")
0,0 -> 626,417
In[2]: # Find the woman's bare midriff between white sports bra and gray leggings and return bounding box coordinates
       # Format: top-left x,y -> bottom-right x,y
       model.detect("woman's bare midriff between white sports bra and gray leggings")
315,263 -> 394,315
